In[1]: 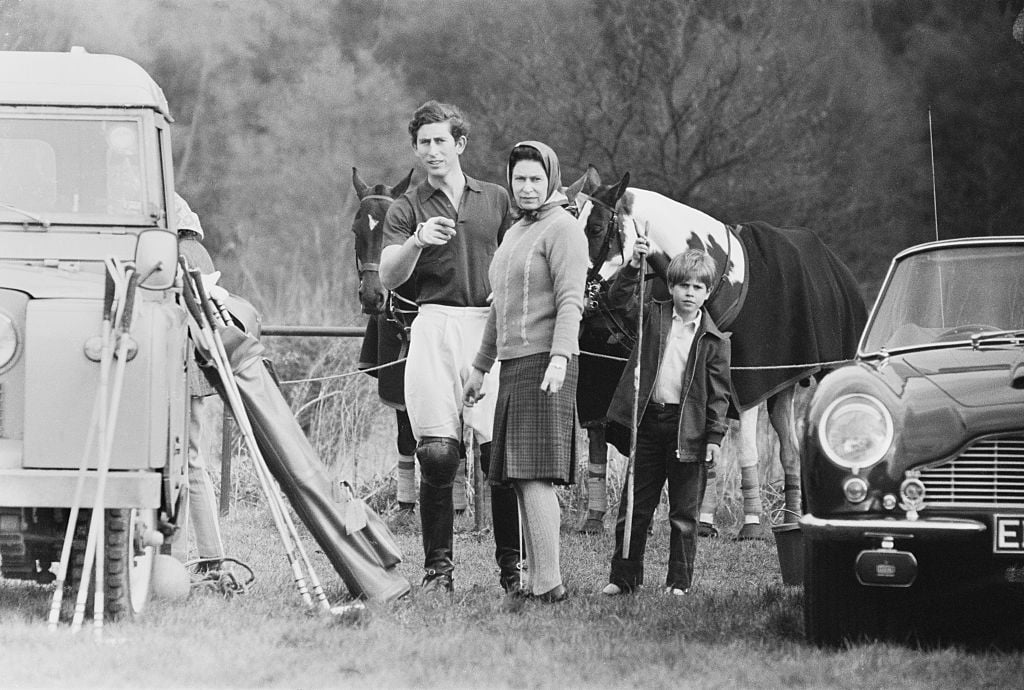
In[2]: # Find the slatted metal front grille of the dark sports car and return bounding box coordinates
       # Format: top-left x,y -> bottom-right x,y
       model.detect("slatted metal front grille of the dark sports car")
921,436 -> 1024,509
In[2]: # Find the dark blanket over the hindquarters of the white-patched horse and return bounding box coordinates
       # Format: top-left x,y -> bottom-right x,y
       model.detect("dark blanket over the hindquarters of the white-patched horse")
719,221 -> 867,411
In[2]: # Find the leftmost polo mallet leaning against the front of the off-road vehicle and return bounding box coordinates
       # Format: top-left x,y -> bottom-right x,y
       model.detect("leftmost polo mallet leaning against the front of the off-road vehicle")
48,265 -> 120,631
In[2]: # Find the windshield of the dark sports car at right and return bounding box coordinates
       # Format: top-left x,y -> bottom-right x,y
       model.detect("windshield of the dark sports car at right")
862,245 -> 1024,352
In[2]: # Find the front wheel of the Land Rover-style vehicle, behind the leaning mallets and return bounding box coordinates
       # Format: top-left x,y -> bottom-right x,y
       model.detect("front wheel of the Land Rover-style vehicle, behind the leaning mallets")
68,508 -> 157,620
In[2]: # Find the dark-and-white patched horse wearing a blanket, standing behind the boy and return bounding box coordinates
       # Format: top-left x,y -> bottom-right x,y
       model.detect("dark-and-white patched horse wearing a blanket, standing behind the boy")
570,167 -> 867,537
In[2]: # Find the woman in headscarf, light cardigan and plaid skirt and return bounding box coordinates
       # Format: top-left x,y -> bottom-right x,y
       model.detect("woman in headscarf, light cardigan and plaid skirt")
464,141 -> 588,603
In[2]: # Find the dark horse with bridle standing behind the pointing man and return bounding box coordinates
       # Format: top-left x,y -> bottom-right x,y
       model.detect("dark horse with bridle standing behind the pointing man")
352,168 -> 416,526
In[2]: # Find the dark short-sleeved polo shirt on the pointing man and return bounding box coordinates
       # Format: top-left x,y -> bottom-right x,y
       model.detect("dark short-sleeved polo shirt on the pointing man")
382,175 -> 512,307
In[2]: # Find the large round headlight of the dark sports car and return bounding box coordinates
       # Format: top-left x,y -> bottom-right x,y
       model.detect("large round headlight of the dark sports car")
818,393 -> 893,470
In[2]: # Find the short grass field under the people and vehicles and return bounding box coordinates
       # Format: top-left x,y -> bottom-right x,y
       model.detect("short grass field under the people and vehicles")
0,497 -> 1024,690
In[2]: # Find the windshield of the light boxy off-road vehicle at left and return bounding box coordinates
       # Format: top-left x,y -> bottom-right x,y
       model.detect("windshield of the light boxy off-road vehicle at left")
0,115 -> 162,225
